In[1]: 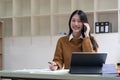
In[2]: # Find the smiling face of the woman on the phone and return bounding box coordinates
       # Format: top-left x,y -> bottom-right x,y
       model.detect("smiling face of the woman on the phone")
71,14 -> 83,33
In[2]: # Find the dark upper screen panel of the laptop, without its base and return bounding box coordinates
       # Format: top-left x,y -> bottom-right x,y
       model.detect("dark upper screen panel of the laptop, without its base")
71,52 -> 107,66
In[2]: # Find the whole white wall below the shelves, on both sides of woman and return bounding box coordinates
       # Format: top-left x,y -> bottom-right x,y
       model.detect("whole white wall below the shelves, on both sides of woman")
3,33 -> 120,69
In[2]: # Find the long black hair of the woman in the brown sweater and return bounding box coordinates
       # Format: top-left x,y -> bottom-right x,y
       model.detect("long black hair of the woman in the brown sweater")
68,10 -> 98,50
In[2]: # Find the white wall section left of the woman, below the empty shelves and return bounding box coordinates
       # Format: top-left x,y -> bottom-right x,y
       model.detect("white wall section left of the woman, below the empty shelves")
3,36 -> 58,69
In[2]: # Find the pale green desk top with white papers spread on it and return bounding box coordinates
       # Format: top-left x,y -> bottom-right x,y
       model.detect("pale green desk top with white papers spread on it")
0,70 -> 120,80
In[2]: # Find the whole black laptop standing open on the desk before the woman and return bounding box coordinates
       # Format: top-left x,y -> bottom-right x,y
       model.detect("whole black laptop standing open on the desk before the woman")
69,52 -> 107,74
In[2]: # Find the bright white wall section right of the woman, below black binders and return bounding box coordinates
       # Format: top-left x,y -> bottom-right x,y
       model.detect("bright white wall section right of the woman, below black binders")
94,33 -> 120,63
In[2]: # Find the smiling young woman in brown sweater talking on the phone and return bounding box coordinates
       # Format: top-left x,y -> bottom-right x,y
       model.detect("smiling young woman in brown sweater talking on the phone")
49,10 -> 98,70
